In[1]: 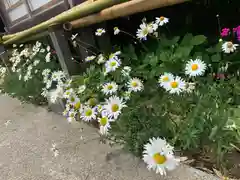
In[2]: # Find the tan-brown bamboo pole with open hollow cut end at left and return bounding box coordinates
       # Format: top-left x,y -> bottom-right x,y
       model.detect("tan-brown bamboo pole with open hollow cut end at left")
68,0 -> 189,29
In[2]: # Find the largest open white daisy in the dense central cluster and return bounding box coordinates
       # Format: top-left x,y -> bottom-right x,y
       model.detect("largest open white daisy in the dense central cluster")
104,96 -> 126,119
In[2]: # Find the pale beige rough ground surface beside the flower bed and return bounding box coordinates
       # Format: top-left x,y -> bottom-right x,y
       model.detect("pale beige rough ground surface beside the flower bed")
0,95 -> 218,180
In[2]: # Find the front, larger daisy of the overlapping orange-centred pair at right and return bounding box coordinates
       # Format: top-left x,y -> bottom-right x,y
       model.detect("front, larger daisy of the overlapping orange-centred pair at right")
164,76 -> 186,94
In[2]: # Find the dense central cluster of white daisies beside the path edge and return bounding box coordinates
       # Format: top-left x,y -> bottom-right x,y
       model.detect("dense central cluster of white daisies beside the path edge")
63,51 -> 144,135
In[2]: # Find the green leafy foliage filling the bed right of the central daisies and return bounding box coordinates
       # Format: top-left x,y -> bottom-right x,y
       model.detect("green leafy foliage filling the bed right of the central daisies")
109,34 -> 240,166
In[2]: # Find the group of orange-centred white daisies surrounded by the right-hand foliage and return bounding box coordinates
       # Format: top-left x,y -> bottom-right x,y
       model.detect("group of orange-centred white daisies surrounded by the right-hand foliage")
159,59 -> 207,94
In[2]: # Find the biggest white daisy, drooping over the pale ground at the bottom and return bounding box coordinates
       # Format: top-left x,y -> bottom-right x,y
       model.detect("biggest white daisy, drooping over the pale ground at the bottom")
143,138 -> 180,175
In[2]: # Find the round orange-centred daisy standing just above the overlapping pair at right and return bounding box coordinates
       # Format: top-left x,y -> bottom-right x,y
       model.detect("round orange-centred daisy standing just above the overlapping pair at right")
185,59 -> 207,77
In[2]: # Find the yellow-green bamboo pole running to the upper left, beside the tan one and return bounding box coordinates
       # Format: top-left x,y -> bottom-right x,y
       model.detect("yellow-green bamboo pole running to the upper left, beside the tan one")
3,0 -> 122,44
